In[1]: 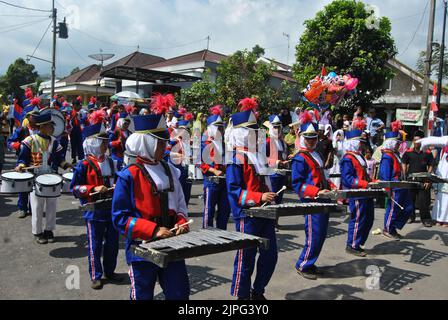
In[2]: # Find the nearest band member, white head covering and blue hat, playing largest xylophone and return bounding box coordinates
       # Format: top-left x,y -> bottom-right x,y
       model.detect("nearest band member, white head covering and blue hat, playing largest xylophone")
112,107 -> 190,300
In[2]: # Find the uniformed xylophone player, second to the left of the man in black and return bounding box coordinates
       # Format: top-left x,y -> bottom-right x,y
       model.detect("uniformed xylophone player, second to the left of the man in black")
340,120 -> 375,257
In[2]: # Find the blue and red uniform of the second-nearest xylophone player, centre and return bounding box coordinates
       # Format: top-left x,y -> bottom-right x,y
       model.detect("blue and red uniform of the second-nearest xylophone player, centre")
226,149 -> 278,299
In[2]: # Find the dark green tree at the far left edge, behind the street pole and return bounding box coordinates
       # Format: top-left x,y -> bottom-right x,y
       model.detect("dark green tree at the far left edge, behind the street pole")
0,58 -> 39,96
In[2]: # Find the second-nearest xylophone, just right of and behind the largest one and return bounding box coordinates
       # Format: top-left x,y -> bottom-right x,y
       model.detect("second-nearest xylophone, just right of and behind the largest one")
243,202 -> 346,220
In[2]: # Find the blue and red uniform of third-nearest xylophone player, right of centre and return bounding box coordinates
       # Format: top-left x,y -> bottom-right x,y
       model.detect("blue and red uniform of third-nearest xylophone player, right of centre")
292,149 -> 334,272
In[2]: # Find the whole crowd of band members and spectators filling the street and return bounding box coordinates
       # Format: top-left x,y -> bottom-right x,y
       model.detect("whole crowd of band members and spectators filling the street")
0,90 -> 448,300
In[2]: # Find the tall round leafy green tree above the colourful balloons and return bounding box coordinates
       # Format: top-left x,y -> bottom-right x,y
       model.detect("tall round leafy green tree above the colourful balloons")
293,0 -> 397,107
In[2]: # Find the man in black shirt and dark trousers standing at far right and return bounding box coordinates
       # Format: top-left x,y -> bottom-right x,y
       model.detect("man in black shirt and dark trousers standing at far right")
403,133 -> 434,227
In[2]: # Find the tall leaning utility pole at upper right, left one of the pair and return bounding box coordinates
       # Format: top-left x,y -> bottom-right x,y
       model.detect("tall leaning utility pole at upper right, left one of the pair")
422,0 -> 436,132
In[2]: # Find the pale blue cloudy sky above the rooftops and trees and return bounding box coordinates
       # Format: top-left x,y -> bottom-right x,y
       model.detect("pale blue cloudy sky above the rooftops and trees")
0,0 -> 443,78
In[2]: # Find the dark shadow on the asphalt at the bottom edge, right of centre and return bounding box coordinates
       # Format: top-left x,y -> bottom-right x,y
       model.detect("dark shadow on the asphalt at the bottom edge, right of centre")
285,284 -> 363,300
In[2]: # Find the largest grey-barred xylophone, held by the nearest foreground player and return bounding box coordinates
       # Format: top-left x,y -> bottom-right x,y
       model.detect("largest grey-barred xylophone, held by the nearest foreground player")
131,228 -> 269,268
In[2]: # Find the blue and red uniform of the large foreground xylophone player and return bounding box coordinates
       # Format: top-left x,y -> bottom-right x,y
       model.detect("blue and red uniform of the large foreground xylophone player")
112,158 -> 190,300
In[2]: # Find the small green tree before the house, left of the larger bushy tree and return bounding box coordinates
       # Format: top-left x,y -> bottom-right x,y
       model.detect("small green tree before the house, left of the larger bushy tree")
179,70 -> 216,114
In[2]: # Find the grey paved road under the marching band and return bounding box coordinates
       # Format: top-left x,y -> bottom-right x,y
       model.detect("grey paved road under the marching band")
0,151 -> 448,300
